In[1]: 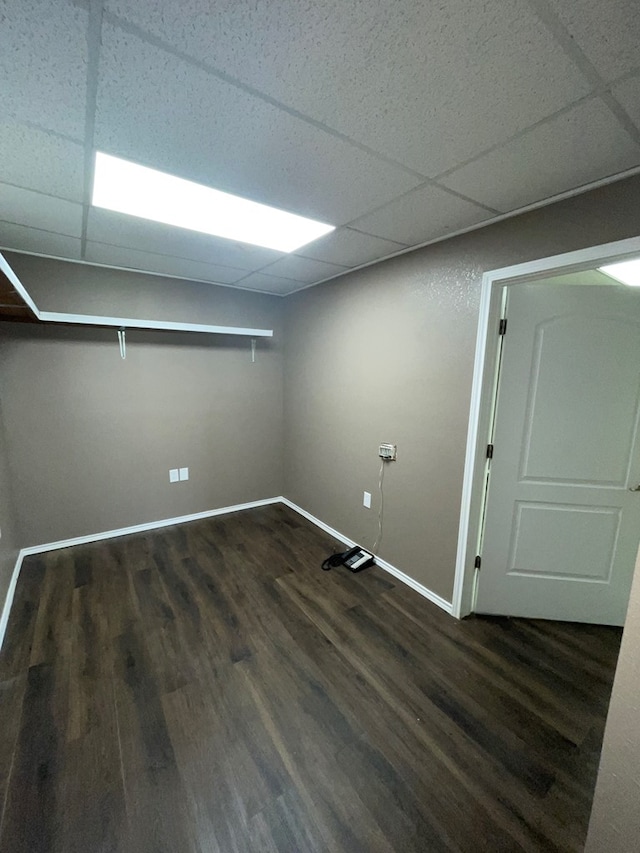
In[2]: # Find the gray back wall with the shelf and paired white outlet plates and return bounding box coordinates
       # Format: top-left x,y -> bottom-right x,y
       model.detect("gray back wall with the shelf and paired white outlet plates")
0,264 -> 283,545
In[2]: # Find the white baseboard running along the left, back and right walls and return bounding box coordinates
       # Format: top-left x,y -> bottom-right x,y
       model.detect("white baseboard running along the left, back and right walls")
0,496 -> 452,649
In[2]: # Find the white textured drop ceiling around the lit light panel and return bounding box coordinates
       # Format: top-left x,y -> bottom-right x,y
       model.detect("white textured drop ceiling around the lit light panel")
0,0 -> 640,295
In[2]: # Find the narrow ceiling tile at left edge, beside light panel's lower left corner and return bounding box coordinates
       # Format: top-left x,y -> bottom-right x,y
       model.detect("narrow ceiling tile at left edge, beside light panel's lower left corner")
0,184 -> 82,237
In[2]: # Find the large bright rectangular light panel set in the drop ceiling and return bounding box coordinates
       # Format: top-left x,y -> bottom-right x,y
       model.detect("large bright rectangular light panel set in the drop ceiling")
92,151 -> 335,252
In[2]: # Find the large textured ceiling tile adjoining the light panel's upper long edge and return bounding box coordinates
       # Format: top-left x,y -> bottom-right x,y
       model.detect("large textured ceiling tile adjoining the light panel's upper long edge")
95,26 -> 417,225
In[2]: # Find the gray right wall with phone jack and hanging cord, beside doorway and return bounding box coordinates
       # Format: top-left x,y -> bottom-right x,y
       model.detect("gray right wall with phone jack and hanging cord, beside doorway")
284,178 -> 640,600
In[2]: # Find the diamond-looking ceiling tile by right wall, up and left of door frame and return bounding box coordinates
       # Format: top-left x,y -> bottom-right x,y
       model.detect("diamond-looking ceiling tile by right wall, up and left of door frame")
353,186 -> 492,245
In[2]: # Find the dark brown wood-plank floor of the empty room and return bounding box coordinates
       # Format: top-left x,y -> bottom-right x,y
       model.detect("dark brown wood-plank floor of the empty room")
0,505 -> 620,853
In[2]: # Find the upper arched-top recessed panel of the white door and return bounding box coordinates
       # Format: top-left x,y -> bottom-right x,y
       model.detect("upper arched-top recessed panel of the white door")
520,316 -> 640,487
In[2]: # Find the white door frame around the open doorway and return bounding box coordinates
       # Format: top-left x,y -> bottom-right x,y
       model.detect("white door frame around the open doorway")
452,236 -> 640,619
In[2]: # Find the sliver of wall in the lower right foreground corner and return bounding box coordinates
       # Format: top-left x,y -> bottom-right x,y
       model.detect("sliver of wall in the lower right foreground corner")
585,552 -> 640,853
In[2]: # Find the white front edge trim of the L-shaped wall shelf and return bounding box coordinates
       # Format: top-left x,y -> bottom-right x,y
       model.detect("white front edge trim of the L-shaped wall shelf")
0,252 -> 273,338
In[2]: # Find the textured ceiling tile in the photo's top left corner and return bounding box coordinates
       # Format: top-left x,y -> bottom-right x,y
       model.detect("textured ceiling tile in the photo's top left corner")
0,0 -> 88,139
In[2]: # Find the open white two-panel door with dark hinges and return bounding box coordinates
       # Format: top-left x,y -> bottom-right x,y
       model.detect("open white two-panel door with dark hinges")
475,284 -> 640,625
